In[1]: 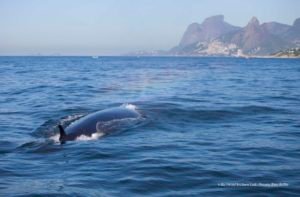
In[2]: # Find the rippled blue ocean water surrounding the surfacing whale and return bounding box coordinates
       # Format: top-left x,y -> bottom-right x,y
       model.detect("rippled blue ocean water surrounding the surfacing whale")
0,57 -> 300,196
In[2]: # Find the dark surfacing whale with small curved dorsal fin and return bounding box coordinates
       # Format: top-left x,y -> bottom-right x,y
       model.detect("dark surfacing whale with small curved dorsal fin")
58,106 -> 141,143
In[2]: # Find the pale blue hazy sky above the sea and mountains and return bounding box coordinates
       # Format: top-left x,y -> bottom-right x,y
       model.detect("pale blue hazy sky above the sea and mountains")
0,0 -> 300,55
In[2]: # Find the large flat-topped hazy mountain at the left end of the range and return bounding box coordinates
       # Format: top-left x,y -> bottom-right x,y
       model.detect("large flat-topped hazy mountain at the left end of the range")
172,15 -> 239,53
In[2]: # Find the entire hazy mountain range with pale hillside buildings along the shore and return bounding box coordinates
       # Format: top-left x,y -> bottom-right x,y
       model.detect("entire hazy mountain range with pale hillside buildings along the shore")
168,15 -> 300,56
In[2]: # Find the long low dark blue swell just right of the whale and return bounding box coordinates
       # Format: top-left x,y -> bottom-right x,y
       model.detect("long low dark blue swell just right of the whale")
147,103 -> 292,124
